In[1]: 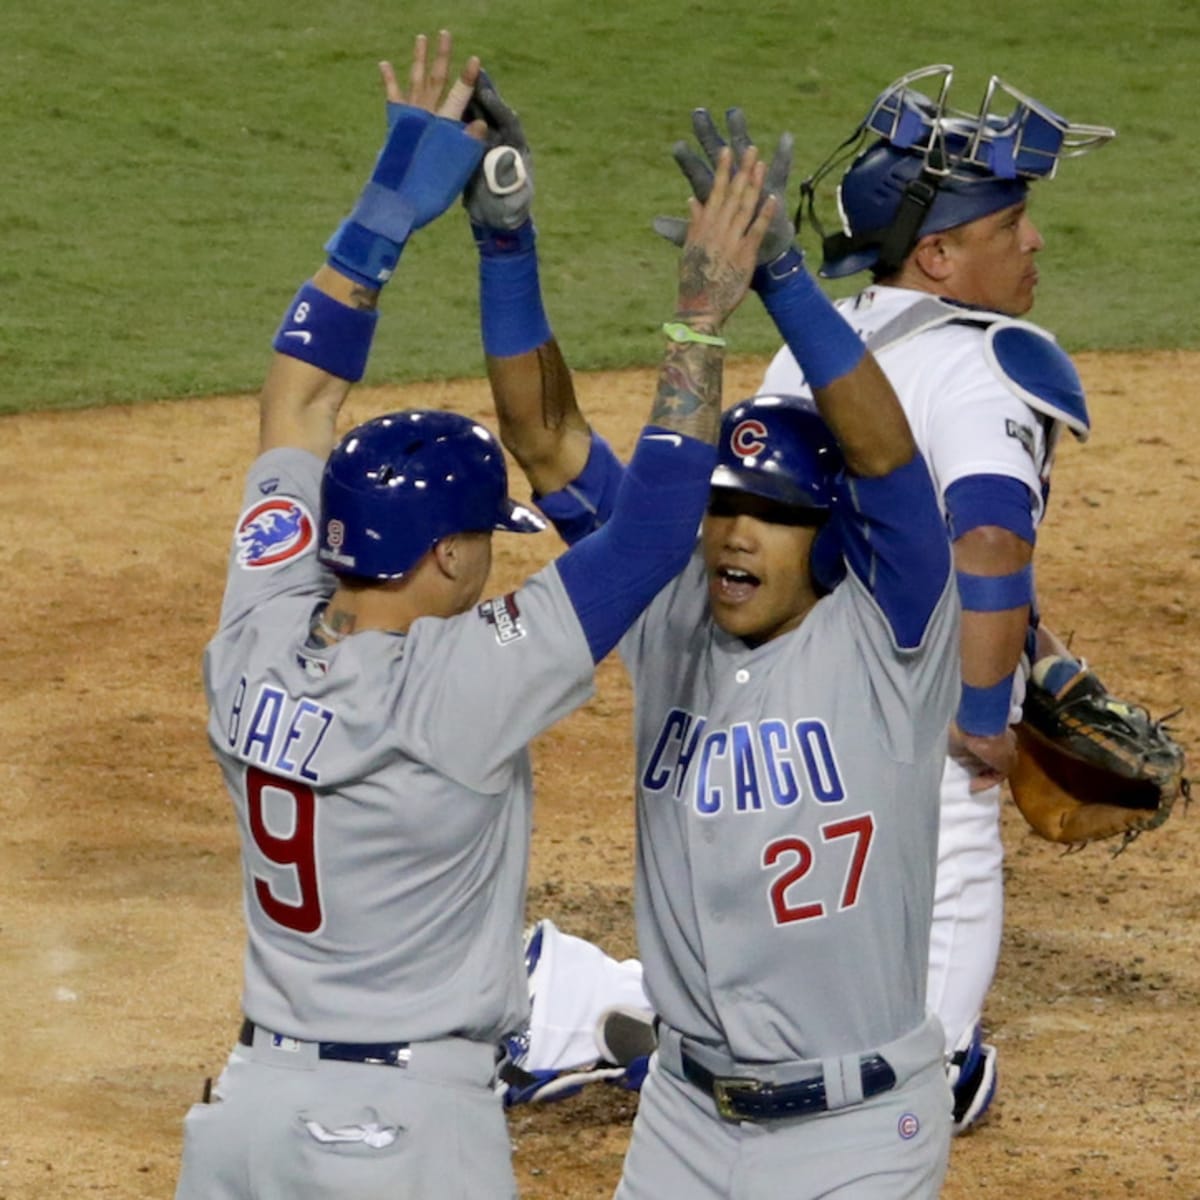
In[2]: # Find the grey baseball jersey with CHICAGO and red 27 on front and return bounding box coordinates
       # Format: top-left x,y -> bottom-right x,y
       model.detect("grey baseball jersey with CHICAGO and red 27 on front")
622,544 -> 958,1063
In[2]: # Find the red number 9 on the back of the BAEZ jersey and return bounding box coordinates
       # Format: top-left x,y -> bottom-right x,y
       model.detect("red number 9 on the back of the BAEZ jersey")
246,767 -> 324,934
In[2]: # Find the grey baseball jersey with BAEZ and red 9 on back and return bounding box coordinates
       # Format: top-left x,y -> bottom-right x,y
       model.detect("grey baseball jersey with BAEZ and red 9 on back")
212,449 -> 593,1043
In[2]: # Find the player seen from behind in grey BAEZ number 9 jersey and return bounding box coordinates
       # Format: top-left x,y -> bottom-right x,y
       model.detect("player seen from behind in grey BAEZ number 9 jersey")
176,34 -> 773,1200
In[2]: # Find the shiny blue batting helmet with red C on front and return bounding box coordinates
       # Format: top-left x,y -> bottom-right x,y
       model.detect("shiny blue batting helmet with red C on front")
709,396 -> 846,593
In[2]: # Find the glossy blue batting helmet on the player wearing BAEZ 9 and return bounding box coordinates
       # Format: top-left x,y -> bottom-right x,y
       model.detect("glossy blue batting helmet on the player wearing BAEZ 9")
317,409 -> 545,580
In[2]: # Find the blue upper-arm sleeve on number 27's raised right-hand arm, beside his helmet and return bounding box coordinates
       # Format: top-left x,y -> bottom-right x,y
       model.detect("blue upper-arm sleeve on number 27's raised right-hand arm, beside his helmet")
835,455 -> 950,648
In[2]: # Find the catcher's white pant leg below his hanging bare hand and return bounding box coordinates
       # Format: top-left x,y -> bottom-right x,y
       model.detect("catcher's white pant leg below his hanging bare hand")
926,758 -> 1004,1052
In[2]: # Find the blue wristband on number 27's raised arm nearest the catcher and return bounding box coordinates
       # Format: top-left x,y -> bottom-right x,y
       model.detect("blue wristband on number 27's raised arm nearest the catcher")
751,246 -> 866,388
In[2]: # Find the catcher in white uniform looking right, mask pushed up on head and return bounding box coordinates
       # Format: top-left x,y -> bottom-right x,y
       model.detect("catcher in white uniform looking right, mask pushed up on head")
762,66 -> 1114,1133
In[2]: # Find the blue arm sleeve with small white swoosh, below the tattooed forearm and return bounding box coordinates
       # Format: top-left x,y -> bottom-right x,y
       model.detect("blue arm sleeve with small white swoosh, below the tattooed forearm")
558,426 -> 716,662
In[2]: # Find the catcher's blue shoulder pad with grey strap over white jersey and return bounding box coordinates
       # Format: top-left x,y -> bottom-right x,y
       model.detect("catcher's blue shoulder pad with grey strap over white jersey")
865,296 -> 1091,442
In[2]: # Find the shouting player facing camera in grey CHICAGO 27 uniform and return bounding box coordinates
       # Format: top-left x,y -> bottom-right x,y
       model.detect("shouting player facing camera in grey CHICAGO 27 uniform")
482,98 -> 959,1200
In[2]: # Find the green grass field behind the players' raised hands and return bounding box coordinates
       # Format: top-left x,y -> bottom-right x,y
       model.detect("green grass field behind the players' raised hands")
0,0 -> 1200,412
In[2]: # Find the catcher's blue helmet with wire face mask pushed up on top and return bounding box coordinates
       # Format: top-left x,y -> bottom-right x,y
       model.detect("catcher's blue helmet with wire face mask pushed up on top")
796,65 -> 1116,278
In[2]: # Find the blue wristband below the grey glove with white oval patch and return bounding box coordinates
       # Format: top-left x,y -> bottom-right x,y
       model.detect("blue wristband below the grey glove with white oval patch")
473,221 -> 552,359
